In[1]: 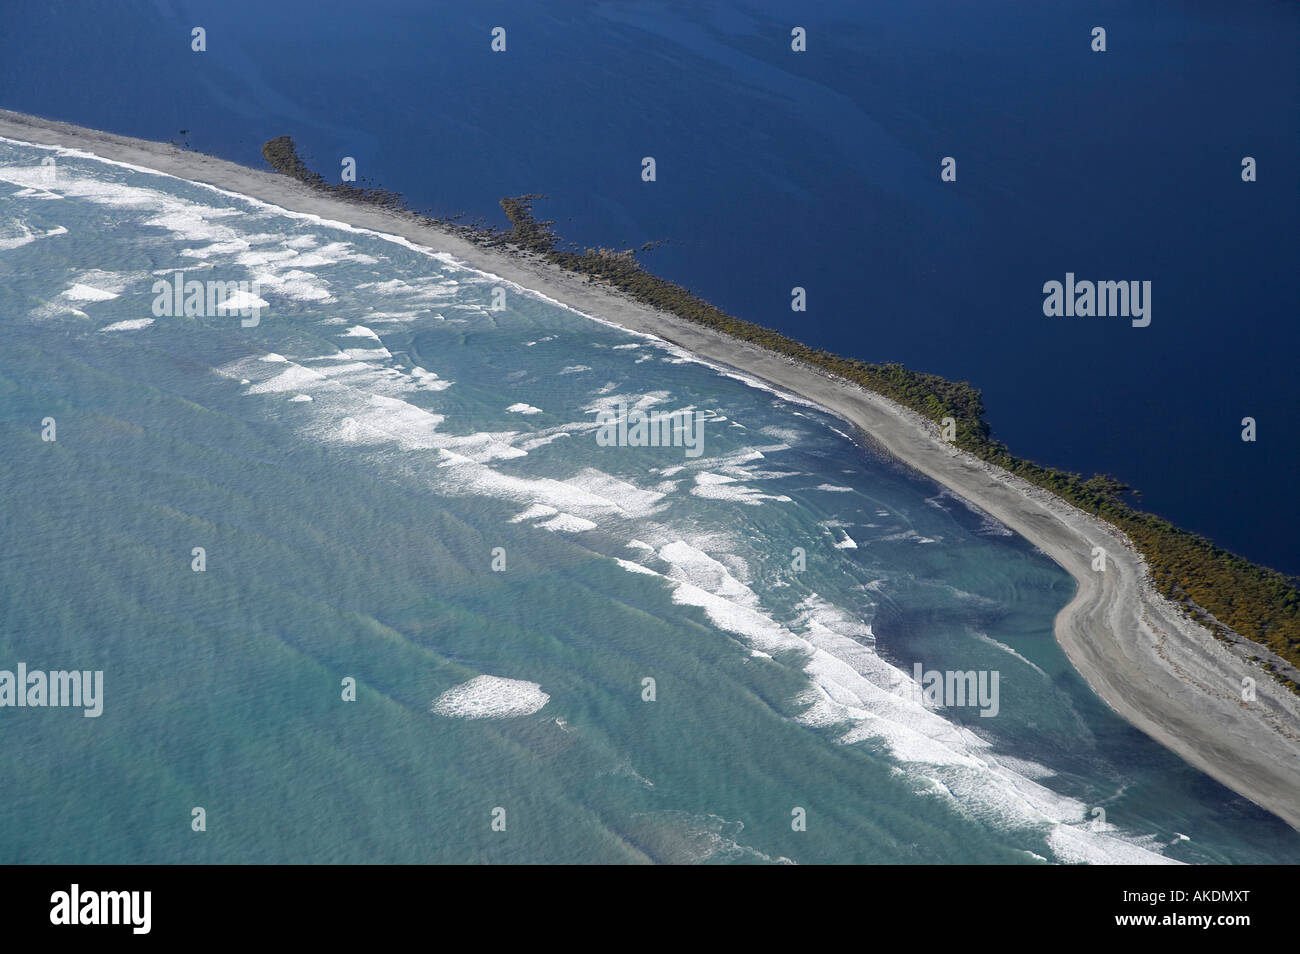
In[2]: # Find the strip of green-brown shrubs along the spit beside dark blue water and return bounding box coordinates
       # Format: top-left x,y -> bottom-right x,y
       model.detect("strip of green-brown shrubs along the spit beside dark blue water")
263,136 -> 1300,693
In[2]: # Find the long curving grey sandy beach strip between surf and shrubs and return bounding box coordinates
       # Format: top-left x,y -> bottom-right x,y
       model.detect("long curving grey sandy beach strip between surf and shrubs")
0,110 -> 1300,829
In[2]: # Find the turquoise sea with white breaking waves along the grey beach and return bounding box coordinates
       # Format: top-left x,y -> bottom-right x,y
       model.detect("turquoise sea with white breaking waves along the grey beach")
0,140 -> 1300,863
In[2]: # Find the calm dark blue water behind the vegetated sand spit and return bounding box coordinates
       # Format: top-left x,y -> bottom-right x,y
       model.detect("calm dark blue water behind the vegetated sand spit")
0,0 -> 1300,572
